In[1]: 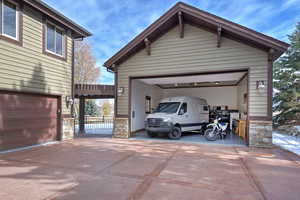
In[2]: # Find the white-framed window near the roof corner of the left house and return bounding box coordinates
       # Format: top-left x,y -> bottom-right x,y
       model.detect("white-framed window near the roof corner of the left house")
45,22 -> 65,57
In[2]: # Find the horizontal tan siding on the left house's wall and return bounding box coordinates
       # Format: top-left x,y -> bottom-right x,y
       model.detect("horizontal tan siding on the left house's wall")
0,5 -> 72,114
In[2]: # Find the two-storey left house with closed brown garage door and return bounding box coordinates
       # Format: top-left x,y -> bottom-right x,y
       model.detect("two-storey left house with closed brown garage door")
0,0 -> 91,150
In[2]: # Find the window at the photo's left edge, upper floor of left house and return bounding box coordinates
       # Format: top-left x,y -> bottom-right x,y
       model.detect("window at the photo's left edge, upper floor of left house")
0,0 -> 20,40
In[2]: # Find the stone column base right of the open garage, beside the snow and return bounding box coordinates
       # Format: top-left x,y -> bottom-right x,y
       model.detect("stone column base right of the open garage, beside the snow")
249,120 -> 273,147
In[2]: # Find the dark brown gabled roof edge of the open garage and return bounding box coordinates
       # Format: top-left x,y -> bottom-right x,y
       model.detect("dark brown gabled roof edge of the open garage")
103,2 -> 289,69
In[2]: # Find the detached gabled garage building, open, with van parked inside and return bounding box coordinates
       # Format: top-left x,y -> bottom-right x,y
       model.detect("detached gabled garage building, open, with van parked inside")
104,2 -> 288,146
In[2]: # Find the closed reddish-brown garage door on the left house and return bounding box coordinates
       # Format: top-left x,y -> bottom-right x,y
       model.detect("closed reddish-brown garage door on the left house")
0,91 -> 58,150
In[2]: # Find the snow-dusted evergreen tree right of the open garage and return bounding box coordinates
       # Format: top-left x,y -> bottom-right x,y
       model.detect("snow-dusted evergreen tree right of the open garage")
273,22 -> 300,125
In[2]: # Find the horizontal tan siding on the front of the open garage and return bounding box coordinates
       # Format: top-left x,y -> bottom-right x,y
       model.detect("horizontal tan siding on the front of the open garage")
117,24 -> 268,116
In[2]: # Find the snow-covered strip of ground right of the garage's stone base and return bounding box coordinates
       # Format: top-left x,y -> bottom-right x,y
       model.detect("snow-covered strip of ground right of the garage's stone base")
273,132 -> 300,156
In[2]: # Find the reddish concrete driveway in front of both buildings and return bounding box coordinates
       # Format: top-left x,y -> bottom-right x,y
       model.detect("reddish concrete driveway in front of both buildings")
0,138 -> 300,200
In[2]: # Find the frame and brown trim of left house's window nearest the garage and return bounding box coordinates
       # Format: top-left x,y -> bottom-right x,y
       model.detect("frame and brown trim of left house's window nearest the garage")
43,19 -> 67,61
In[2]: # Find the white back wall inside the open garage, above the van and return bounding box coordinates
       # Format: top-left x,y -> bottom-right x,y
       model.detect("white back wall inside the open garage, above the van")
163,86 -> 238,109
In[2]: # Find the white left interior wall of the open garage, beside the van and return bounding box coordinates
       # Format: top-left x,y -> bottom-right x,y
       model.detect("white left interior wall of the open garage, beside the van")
131,80 -> 162,131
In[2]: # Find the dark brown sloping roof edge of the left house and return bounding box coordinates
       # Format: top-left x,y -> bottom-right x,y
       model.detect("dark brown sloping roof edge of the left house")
23,0 -> 92,38
